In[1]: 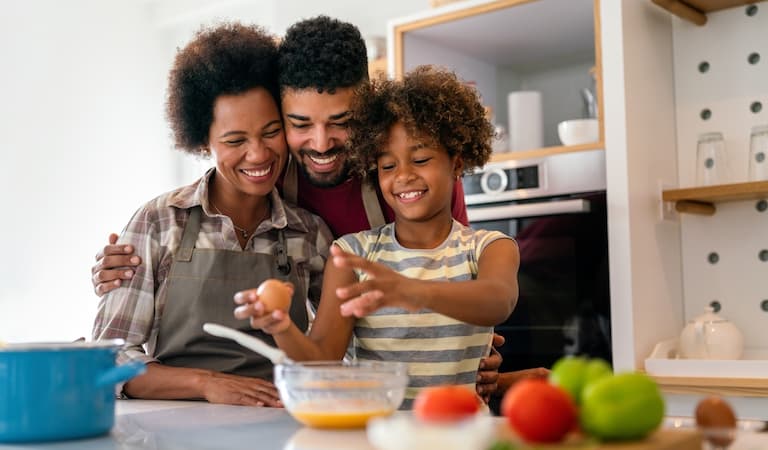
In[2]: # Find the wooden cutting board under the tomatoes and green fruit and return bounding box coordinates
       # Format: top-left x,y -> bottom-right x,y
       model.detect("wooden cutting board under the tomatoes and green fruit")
497,423 -> 702,450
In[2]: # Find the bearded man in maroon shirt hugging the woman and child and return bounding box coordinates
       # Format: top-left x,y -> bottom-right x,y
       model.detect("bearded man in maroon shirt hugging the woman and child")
92,16 -> 503,396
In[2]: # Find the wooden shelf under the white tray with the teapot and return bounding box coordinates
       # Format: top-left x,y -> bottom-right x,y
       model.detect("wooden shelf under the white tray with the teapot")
651,375 -> 768,398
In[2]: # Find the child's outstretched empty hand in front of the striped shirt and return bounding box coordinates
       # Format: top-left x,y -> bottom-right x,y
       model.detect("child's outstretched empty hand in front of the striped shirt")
331,245 -> 423,317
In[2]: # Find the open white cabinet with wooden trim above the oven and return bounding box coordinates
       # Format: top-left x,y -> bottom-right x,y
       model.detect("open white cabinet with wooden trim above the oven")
388,0 -> 603,160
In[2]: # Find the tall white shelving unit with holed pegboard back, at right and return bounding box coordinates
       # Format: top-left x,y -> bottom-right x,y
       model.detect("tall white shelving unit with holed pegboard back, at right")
600,0 -> 768,419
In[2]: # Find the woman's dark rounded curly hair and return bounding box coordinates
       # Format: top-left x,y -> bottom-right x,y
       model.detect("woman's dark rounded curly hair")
166,22 -> 280,155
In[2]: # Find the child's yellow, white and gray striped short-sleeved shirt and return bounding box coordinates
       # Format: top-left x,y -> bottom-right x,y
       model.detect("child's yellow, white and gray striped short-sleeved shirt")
335,220 -> 511,409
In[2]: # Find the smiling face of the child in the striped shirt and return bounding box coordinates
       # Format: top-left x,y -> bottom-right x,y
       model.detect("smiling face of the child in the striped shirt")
377,122 -> 461,222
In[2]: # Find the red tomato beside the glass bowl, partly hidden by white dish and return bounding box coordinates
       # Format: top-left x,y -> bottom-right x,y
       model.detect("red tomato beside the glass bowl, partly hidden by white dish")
413,386 -> 480,422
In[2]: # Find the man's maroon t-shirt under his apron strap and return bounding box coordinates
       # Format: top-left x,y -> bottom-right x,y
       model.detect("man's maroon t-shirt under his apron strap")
278,170 -> 469,237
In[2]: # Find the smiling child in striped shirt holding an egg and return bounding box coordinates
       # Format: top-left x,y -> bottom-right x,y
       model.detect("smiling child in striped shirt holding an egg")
235,67 -> 519,408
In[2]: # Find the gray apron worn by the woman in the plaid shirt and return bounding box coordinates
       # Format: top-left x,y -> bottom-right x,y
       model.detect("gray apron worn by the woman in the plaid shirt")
155,206 -> 308,380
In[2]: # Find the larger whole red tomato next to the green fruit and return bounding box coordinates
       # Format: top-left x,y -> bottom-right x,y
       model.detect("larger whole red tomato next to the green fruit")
501,379 -> 578,442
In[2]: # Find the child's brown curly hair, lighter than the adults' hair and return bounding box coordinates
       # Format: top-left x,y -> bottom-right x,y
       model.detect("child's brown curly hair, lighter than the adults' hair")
349,66 -> 494,183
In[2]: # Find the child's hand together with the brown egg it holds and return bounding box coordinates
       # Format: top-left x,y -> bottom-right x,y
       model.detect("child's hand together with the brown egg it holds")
235,278 -> 293,334
